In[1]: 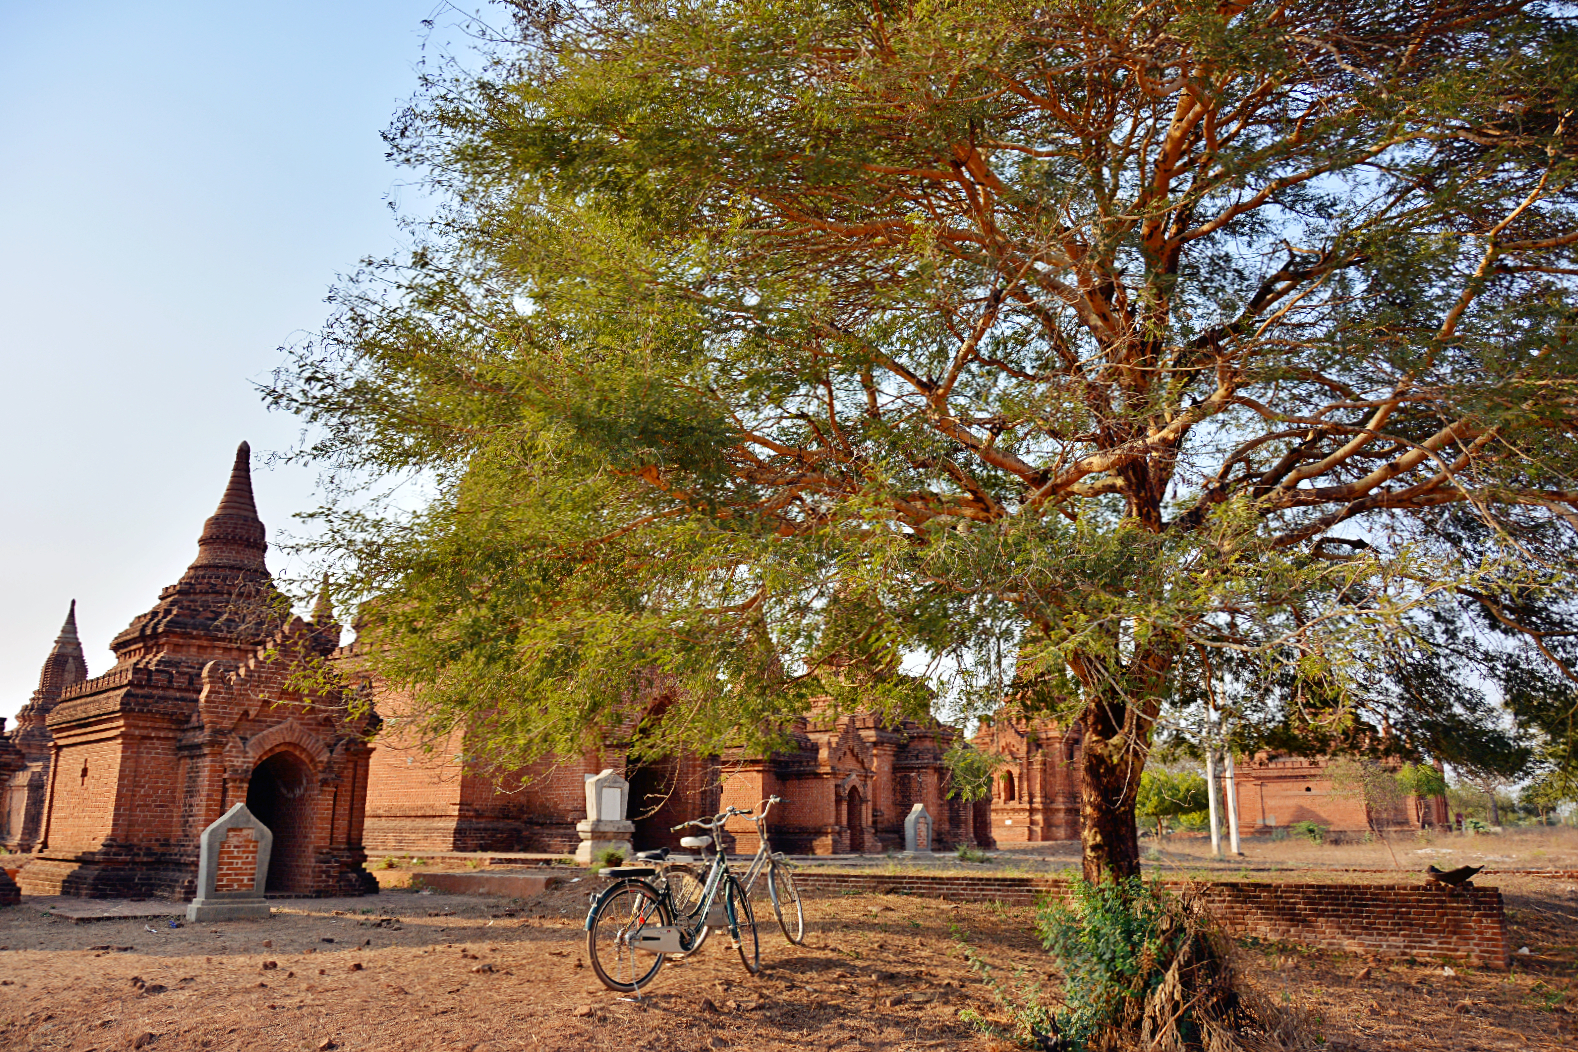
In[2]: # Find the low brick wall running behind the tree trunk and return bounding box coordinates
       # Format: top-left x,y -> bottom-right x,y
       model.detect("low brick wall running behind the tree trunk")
795,869 -> 1512,968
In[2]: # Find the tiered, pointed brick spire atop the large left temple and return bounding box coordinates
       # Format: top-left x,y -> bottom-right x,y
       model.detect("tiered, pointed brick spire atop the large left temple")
110,442 -> 289,662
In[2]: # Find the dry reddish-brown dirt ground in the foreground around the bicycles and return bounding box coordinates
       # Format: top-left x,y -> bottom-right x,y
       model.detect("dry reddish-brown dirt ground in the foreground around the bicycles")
0,877 -> 1578,1052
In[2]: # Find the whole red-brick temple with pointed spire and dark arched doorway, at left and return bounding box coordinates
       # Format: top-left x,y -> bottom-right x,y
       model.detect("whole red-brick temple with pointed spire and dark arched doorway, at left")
21,443 -> 377,897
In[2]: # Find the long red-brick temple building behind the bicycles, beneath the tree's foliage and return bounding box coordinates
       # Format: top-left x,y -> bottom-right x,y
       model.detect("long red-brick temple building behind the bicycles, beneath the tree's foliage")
361,687 -> 965,855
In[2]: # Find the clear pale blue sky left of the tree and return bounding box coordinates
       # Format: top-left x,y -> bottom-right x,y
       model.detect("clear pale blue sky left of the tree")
0,0 -> 466,718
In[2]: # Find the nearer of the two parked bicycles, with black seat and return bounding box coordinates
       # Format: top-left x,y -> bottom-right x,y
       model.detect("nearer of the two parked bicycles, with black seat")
585,808 -> 762,994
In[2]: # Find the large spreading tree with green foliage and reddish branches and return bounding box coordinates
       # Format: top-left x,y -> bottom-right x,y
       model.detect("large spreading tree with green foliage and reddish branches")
271,0 -> 1578,880
